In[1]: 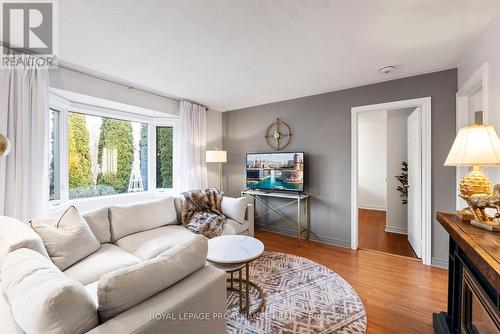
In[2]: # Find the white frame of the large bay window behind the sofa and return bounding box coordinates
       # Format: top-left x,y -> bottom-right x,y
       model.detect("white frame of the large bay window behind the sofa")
47,92 -> 178,207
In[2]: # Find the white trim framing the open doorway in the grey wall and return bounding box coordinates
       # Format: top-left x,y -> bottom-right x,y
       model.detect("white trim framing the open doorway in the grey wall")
351,97 -> 433,265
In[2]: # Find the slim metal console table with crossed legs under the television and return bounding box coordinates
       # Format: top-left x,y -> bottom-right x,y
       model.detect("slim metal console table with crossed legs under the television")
241,189 -> 311,242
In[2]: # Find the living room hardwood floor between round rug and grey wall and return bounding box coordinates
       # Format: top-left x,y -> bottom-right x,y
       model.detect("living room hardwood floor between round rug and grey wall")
255,230 -> 448,334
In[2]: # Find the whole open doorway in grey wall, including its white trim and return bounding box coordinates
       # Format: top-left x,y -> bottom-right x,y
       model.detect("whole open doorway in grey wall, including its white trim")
351,97 -> 432,265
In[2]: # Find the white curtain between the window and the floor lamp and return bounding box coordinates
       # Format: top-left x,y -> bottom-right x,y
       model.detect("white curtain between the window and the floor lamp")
175,101 -> 207,192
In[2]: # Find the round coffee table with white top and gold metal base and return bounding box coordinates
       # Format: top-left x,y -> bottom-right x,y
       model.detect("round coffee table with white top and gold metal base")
207,235 -> 264,316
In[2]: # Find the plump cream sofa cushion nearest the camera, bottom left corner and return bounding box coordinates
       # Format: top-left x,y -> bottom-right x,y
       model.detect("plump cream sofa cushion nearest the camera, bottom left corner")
1,248 -> 99,334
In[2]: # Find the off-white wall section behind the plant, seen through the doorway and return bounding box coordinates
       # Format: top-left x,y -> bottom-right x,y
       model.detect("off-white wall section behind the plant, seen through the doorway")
386,109 -> 413,234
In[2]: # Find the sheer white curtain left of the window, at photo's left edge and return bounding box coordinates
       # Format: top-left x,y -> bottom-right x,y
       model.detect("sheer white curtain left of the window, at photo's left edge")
0,68 -> 49,221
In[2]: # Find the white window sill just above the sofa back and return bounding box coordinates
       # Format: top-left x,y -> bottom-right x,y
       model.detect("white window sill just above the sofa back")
48,189 -> 175,217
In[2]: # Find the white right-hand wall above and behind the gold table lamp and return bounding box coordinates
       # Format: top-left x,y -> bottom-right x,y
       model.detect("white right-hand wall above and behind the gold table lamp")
458,11 -> 500,183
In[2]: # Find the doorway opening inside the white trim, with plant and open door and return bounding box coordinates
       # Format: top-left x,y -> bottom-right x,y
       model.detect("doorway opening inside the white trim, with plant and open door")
358,107 -> 421,258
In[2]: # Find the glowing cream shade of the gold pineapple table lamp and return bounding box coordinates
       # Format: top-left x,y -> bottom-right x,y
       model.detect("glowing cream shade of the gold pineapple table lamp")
444,125 -> 500,166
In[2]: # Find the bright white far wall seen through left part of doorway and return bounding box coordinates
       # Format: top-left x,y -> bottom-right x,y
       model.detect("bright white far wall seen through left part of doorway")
358,110 -> 387,210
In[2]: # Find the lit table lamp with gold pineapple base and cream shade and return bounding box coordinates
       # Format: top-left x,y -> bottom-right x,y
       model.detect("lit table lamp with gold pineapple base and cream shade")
444,125 -> 500,230
